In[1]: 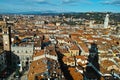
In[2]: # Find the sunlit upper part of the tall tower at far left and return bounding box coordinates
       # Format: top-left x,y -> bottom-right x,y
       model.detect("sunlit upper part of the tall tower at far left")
2,20 -> 11,51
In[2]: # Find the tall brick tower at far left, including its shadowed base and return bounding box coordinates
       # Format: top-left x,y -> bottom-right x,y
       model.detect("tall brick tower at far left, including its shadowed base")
0,16 -> 14,68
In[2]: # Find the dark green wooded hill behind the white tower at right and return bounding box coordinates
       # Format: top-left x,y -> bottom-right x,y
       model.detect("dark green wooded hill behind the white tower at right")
59,12 -> 120,22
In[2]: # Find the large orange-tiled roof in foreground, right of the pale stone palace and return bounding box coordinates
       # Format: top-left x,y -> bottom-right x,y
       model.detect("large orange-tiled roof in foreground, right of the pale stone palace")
28,58 -> 63,80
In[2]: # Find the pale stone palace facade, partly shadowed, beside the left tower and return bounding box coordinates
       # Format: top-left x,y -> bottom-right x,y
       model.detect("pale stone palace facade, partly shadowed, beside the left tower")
11,44 -> 34,71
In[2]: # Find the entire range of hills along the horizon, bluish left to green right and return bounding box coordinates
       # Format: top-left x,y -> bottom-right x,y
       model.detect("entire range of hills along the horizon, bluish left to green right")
0,10 -> 120,23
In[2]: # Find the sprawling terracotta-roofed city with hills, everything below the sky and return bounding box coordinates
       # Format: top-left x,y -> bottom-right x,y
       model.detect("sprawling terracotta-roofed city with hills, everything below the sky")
0,6 -> 120,80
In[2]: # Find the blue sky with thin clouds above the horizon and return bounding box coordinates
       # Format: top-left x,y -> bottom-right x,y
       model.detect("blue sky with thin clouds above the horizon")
0,0 -> 120,12
